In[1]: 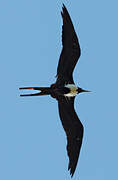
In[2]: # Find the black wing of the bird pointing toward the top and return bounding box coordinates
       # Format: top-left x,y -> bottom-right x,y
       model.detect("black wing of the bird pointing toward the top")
57,5 -> 81,84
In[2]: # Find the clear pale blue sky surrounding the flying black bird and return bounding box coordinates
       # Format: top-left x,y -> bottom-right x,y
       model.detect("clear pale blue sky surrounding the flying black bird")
0,0 -> 118,180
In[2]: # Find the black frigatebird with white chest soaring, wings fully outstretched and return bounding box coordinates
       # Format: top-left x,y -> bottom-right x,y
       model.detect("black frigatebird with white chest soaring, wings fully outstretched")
20,4 -> 89,177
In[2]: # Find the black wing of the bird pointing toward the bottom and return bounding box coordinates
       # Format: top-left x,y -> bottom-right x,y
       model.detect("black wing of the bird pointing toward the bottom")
57,97 -> 83,176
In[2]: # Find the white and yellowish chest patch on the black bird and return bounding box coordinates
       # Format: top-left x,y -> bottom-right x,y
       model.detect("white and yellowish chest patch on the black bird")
64,84 -> 77,97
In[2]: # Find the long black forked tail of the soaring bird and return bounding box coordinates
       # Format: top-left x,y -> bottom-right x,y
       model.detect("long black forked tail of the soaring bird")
19,87 -> 50,96
